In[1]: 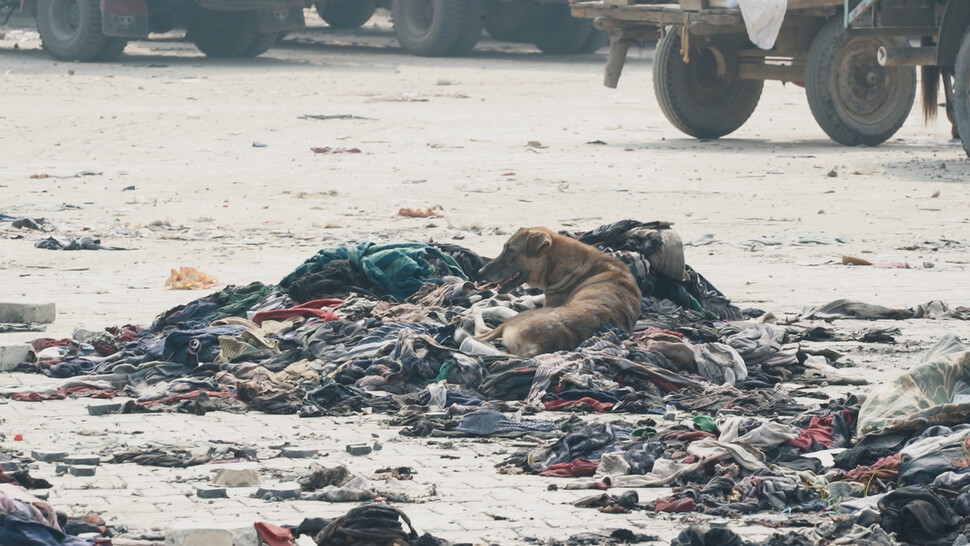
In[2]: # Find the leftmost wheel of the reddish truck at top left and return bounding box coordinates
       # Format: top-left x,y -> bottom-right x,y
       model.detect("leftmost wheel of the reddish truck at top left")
37,0 -> 108,61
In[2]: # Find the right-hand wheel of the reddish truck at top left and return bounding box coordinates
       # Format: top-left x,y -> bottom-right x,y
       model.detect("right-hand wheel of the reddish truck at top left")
186,9 -> 260,58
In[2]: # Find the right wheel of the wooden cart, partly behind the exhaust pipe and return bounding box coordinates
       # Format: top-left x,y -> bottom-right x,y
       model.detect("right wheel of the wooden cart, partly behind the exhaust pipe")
805,17 -> 916,146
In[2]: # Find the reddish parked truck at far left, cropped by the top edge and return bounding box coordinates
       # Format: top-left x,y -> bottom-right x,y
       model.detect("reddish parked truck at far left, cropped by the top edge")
0,0 -> 304,61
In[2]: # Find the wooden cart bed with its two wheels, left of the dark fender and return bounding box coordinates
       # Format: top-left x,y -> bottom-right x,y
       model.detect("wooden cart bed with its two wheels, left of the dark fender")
572,0 -> 932,146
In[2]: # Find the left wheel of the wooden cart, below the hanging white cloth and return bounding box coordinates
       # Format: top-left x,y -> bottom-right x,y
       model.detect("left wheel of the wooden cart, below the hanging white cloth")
653,31 -> 764,138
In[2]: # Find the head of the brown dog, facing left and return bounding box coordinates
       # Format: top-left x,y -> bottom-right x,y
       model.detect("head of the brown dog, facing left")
478,228 -> 553,294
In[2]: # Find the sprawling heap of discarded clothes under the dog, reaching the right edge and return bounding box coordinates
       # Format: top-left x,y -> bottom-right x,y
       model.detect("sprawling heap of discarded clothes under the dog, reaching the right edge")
1,220 -> 970,544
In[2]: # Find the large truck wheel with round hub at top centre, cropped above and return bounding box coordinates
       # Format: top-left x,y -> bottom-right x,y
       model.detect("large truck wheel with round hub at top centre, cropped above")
391,0 -> 471,57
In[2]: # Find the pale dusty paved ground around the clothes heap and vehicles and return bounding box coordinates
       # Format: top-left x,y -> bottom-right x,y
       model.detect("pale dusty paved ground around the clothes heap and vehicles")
0,8 -> 970,544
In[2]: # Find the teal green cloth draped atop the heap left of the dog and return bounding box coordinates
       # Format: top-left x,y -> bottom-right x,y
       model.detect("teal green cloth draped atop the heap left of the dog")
280,242 -> 467,301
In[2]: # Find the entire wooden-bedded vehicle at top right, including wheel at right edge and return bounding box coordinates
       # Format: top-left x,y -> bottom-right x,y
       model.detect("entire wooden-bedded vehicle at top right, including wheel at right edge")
572,0 -> 970,155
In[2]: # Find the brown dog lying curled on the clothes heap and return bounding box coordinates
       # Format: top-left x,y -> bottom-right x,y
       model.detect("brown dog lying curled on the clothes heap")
478,227 -> 640,357
